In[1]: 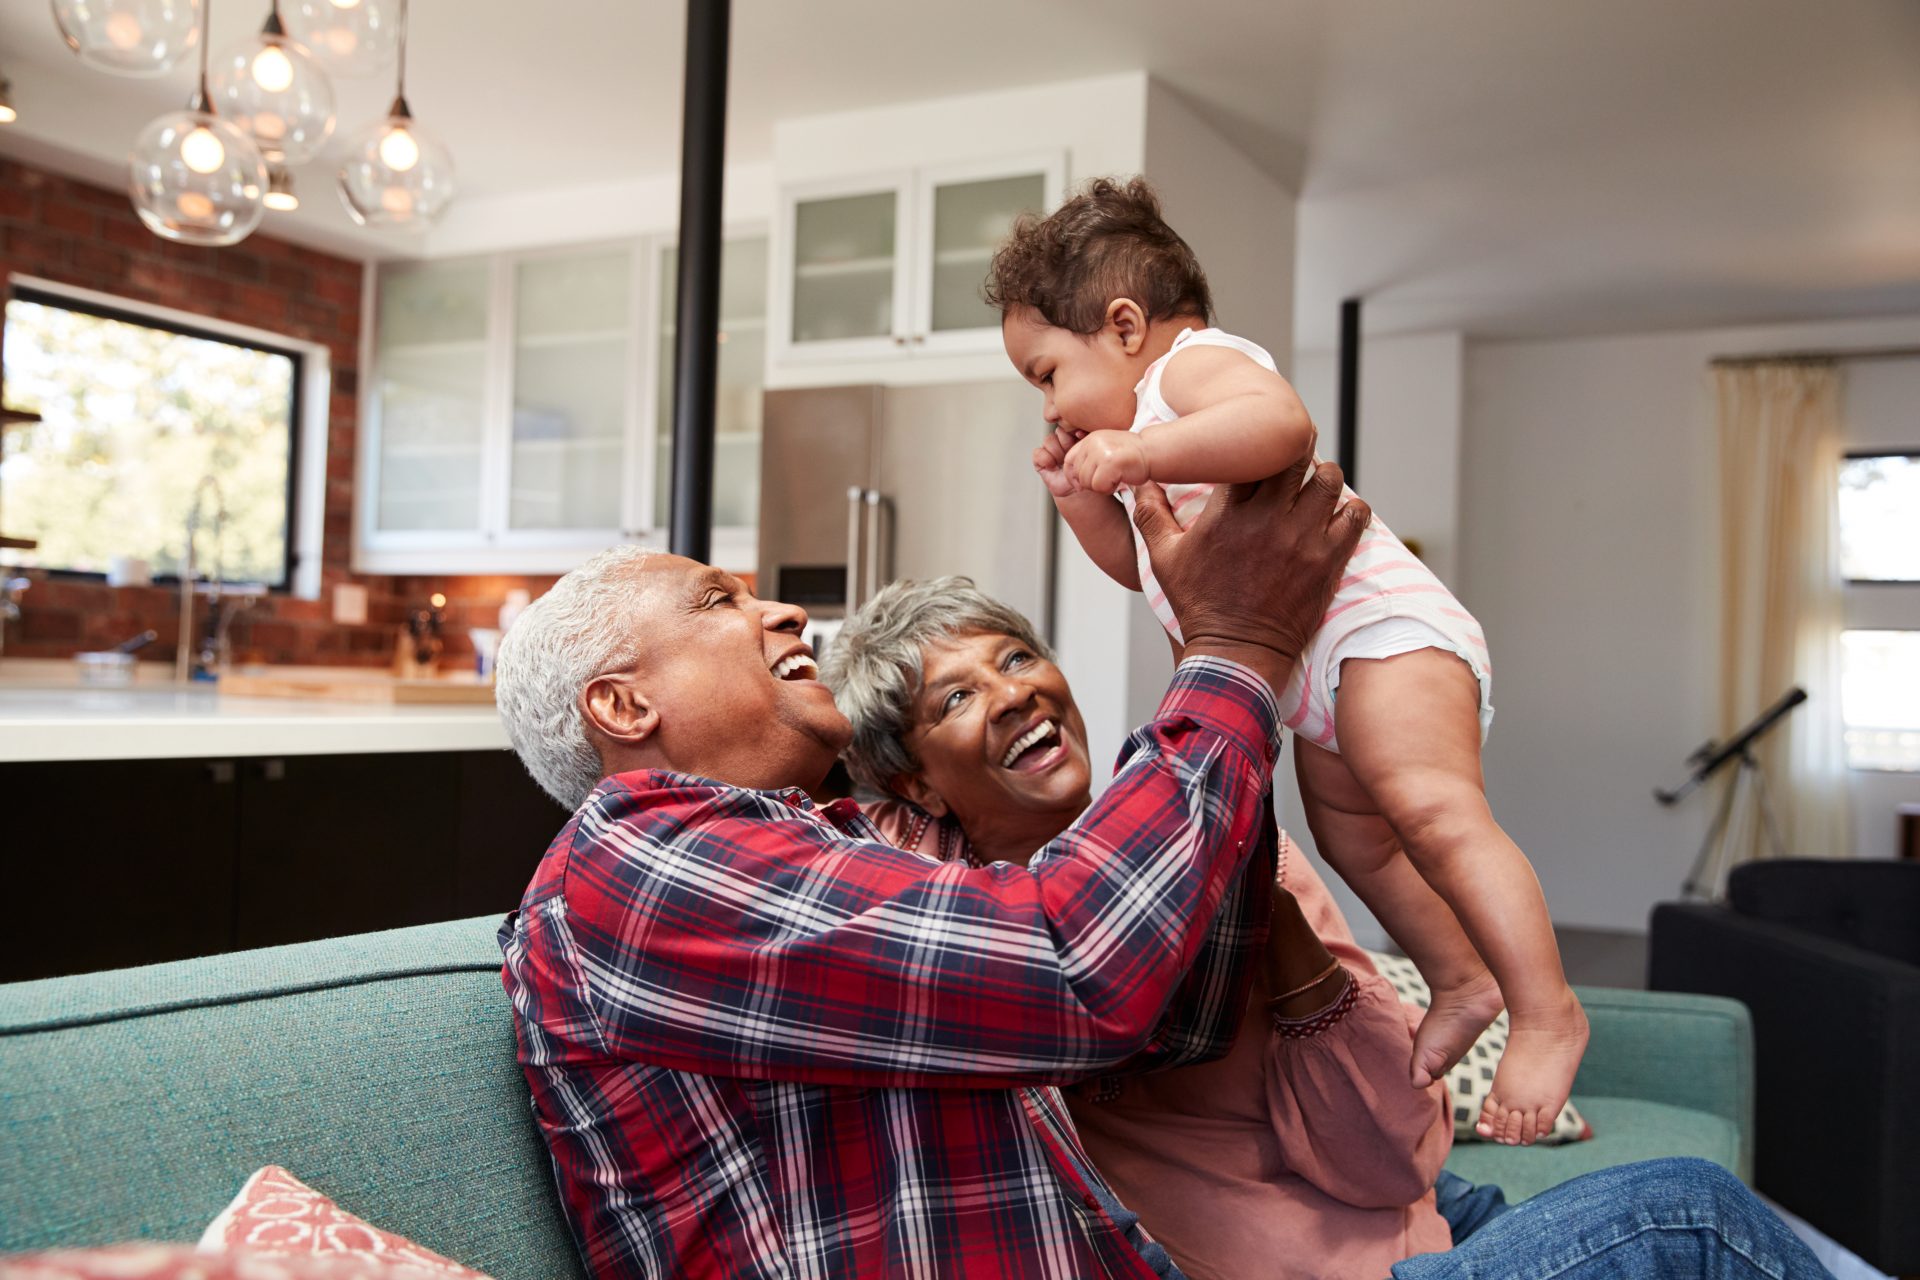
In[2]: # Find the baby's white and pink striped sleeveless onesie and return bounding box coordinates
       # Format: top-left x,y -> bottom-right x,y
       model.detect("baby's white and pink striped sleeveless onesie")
1119,328 -> 1494,752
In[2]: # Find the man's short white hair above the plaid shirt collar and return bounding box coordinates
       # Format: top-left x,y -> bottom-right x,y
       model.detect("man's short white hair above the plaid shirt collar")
493,547 -> 651,810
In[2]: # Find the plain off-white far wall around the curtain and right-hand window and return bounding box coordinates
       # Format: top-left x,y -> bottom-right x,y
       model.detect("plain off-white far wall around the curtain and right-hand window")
1451,310 -> 1920,929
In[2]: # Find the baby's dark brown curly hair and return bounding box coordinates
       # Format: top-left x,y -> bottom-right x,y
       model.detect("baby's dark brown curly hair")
985,178 -> 1213,334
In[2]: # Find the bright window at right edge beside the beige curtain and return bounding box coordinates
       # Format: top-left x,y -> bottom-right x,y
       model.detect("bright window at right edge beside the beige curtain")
1839,451 -> 1920,771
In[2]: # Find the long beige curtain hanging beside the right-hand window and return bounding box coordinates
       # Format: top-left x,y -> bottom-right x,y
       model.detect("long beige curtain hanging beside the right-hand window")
1715,363 -> 1853,865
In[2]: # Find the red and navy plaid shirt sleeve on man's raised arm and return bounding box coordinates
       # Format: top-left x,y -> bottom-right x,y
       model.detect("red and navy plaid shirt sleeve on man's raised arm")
555,658 -> 1279,1088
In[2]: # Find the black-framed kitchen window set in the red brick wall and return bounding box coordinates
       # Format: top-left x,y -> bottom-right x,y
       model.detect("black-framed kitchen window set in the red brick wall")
0,284 -> 303,587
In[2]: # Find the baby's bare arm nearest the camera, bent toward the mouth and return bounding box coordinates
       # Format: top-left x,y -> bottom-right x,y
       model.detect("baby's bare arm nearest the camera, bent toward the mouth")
1066,347 -> 1313,493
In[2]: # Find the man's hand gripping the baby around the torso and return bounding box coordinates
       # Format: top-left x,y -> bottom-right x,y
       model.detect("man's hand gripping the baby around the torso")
1133,459 -> 1373,689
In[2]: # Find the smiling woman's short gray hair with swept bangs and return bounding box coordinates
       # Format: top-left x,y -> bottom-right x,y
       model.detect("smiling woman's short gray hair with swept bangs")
820,578 -> 1054,793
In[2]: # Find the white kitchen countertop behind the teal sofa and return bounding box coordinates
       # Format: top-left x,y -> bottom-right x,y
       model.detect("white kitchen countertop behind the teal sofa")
0,658 -> 509,762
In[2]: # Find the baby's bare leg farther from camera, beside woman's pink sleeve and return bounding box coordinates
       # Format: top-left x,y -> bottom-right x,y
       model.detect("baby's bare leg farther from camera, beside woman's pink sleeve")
1294,739 -> 1500,1088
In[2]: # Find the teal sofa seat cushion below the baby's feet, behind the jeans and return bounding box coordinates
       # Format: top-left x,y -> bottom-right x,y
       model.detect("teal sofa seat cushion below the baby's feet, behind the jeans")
1446,1094 -> 1740,1201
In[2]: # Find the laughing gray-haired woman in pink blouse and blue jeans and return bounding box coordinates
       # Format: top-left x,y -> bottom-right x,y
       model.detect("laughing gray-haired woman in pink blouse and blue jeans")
824,578 -> 1832,1280
